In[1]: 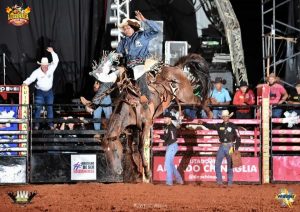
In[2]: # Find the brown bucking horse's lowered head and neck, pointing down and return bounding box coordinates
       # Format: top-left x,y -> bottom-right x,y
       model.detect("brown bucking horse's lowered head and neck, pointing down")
101,97 -> 136,174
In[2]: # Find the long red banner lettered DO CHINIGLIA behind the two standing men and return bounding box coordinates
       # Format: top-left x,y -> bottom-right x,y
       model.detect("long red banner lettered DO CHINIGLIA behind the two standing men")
153,156 -> 260,182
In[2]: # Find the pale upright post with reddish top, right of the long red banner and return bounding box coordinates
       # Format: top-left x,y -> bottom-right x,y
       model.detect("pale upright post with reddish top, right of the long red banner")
262,84 -> 270,183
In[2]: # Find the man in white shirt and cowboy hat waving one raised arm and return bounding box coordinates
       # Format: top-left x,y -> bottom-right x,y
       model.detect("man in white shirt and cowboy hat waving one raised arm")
23,47 -> 59,129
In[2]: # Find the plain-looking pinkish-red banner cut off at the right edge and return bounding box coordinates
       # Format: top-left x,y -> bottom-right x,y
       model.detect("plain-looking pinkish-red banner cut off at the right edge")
272,156 -> 300,181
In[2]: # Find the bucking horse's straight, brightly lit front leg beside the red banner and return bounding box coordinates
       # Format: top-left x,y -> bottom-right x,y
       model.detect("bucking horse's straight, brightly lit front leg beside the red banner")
139,123 -> 152,179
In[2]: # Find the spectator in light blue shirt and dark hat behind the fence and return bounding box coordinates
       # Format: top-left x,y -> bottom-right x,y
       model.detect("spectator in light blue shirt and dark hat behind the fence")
210,77 -> 231,119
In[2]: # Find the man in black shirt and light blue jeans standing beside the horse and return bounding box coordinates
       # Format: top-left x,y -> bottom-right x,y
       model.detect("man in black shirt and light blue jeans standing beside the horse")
162,112 -> 183,185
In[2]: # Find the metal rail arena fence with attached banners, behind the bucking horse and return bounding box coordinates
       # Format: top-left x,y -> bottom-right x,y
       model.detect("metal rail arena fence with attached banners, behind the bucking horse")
0,104 -> 300,184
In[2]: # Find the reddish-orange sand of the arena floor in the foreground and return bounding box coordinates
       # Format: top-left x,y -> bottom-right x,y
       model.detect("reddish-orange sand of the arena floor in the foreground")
0,183 -> 300,212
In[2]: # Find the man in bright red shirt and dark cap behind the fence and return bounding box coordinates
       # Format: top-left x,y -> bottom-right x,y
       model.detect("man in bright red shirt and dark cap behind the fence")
233,81 -> 255,119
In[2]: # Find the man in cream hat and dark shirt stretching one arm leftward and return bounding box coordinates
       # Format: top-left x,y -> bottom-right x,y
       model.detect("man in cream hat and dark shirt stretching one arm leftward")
187,110 -> 241,185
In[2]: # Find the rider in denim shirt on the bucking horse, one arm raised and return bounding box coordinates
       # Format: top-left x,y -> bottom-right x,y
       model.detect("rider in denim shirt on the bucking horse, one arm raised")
117,11 -> 160,107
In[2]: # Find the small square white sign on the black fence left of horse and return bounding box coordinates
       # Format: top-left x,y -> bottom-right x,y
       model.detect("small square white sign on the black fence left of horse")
71,155 -> 97,180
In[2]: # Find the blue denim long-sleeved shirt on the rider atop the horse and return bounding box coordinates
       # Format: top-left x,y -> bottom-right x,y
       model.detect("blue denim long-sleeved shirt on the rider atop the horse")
117,20 -> 160,63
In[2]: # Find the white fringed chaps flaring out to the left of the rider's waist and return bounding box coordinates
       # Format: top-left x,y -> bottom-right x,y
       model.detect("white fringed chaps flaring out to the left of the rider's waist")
89,51 -> 120,81
